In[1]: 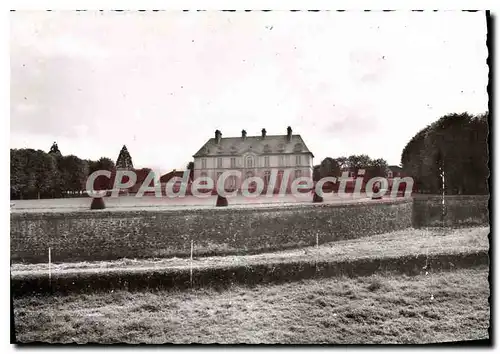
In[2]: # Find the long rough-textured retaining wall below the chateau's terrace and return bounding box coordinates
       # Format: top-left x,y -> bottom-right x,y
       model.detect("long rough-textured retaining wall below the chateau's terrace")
11,198 -> 412,263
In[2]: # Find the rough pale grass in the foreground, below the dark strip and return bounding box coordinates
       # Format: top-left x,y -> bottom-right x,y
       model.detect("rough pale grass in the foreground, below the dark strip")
14,266 -> 490,344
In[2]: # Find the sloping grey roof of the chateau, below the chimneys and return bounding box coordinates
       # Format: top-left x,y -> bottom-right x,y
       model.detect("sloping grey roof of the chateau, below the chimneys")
193,134 -> 314,157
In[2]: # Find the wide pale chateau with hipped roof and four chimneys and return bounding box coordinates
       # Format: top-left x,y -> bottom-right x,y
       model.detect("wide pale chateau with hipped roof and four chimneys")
193,127 -> 314,190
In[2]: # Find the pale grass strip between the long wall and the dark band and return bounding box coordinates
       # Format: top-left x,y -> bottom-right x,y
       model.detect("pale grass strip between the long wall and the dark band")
11,227 -> 489,276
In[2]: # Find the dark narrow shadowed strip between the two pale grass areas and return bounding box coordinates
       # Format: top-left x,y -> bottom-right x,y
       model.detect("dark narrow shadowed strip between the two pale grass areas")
11,251 -> 489,296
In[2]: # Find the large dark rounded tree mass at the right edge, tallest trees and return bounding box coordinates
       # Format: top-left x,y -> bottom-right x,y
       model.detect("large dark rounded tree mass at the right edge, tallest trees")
401,113 -> 489,194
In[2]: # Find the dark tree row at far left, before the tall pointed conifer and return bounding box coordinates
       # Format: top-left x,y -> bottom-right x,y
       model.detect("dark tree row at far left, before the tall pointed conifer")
10,143 -> 115,199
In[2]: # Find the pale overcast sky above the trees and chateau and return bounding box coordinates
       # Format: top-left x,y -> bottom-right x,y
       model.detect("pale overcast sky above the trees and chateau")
10,11 -> 488,171
